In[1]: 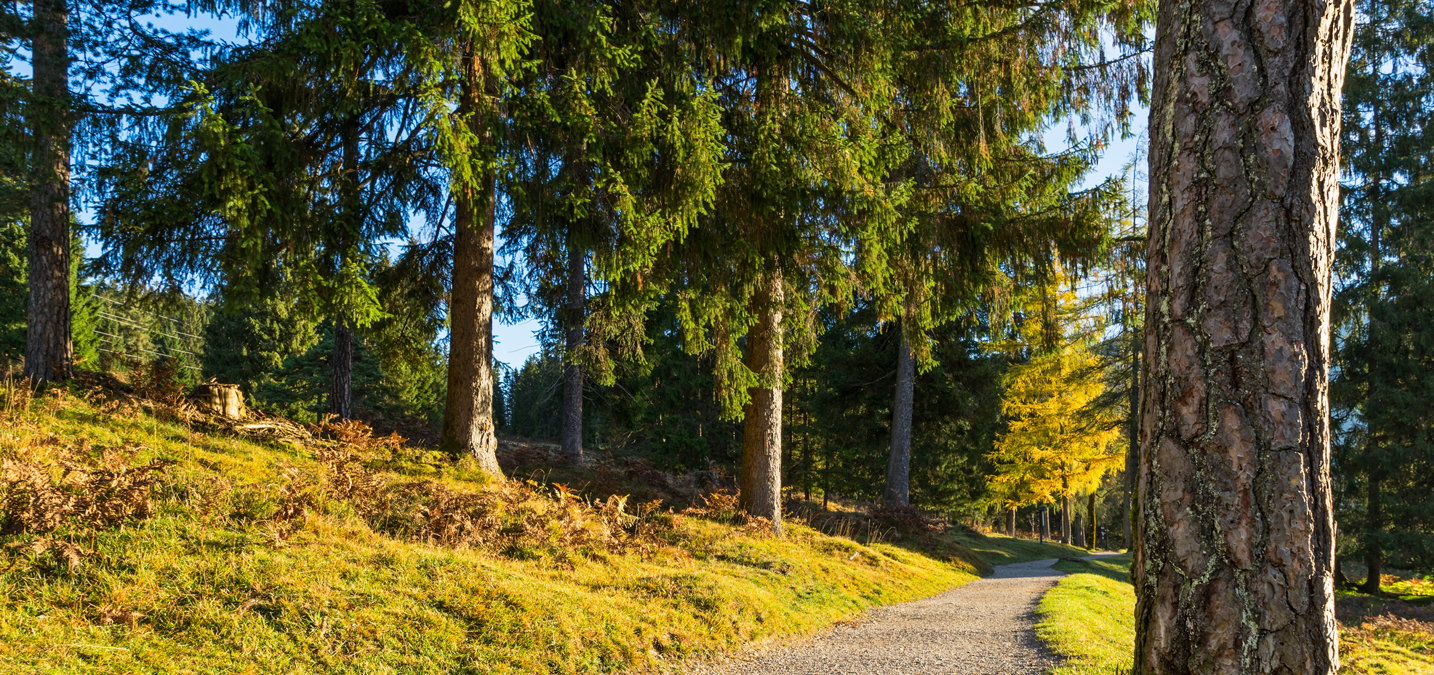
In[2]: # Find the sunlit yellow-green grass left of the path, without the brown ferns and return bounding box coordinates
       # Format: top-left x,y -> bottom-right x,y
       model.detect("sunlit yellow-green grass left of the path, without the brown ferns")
0,386 -> 1078,674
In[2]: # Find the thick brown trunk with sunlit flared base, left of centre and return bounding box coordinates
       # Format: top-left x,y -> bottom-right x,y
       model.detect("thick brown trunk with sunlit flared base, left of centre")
442,52 -> 503,479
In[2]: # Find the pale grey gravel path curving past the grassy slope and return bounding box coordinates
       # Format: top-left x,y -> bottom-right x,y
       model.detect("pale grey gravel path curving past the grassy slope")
694,560 -> 1065,675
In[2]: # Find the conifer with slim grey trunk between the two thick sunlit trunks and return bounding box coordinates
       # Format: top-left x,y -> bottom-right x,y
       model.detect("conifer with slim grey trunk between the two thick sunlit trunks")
505,3 -> 721,460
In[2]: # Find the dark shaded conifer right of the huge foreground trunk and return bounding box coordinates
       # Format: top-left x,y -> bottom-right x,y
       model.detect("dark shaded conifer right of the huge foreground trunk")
1331,0 -> 1434,593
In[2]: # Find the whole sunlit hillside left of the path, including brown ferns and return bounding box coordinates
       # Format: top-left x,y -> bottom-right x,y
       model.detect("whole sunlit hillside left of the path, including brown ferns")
0,377 -> 1078,674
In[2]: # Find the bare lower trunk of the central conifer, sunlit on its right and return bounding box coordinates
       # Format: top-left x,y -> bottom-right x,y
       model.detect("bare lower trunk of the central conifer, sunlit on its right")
741,272 -> 784,532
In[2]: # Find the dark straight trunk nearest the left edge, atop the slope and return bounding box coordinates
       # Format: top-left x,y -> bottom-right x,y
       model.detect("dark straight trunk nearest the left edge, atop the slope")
24,0 -> 75,381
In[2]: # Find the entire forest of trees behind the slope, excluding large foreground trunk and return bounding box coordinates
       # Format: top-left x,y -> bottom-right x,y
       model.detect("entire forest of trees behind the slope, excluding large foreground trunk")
0,0 -> 1434,579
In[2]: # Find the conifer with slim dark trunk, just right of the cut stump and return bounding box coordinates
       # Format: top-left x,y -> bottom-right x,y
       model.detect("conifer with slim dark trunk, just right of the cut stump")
100,0 -> 439,418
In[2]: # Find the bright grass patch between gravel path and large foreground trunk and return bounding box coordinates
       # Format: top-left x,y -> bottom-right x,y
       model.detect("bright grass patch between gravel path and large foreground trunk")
1035,553 -> 1136,675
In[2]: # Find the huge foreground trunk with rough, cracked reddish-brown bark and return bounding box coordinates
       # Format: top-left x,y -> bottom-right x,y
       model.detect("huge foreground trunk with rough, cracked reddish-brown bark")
1133,0 -> 1354,664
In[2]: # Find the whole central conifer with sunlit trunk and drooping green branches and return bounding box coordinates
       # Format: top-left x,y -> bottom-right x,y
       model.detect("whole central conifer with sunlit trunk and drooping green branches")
660,0 -> 895,530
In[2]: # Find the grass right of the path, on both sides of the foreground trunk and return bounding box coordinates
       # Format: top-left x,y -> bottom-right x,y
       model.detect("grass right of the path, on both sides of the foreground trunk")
1035,553 -> 1434,675
